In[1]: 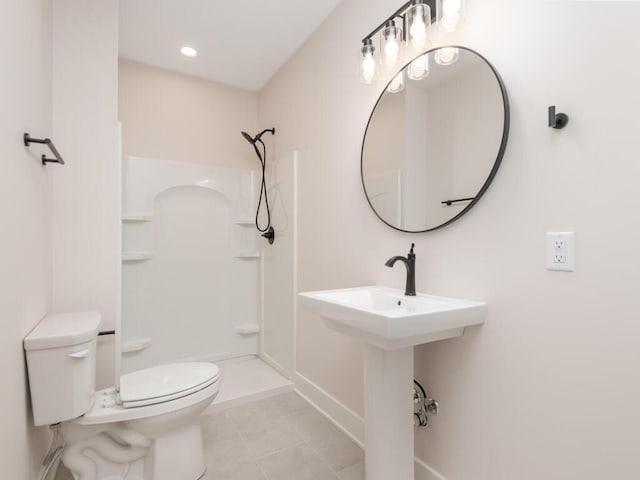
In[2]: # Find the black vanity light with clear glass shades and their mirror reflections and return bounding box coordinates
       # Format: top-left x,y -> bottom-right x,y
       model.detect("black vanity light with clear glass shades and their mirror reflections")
360,0 -> 464,84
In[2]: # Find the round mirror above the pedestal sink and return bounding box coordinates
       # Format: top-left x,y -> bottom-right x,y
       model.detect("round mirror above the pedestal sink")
361,47 -> 509,232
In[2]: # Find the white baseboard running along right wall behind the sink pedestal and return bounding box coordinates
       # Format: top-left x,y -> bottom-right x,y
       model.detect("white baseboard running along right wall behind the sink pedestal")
294,372 -> 447,480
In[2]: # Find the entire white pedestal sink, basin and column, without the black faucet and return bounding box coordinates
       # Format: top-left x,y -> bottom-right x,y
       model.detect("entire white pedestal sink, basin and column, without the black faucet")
299,286 -> 487,480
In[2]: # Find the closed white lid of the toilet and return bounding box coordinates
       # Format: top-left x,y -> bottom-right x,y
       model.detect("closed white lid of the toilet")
120,362 -> 220,408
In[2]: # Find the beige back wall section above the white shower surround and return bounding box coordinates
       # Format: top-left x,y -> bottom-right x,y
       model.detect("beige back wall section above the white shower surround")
118,60 -> 258,169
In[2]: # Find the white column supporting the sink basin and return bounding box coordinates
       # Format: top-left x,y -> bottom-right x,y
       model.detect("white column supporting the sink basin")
364,344 -> 414,480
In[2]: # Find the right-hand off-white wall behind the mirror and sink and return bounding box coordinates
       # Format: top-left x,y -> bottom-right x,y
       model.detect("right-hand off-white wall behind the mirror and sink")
260,0 -> 640,480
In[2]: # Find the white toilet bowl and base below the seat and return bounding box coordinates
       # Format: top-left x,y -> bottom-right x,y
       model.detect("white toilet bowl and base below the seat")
62,376 -> 220,480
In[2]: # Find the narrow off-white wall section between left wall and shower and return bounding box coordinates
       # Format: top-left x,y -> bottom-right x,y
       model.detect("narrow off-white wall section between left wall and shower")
52,0 -> 120,388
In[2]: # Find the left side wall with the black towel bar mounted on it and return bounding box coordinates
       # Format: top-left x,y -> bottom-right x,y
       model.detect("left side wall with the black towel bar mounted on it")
0,0 -> 55,479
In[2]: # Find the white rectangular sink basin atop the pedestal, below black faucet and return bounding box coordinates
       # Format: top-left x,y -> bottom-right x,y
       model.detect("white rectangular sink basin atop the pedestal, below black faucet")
299,286 -> 487,350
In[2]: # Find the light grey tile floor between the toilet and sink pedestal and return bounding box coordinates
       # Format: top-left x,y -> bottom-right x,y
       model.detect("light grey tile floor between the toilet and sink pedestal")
202,392 -> 365,480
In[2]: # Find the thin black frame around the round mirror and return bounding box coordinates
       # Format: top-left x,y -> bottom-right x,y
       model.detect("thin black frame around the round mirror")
360,45 -> 510,233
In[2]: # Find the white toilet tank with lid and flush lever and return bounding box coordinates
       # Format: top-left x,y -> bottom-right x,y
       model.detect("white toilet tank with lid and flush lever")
24,312 -> 100,426
